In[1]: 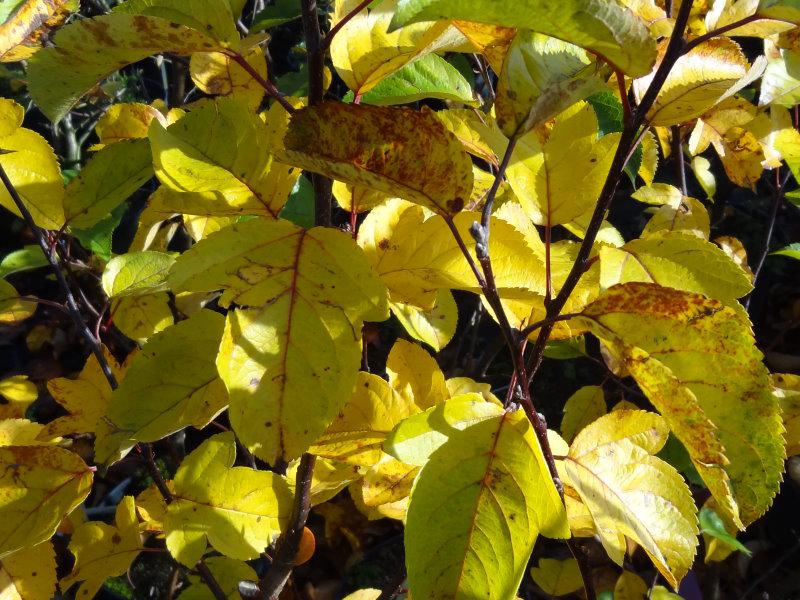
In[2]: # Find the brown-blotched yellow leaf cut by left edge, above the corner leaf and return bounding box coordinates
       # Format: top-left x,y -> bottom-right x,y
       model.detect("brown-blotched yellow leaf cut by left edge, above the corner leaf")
0,446 -> 92,558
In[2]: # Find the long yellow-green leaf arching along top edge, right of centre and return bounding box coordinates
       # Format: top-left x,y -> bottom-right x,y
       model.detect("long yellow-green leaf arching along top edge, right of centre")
390,0 -> 656,77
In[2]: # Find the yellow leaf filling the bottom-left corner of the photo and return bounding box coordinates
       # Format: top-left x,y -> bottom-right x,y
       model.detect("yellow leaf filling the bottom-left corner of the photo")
0,542 -> 56,600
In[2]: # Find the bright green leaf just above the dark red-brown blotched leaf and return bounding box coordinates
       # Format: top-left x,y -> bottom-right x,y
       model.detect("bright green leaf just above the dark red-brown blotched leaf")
344,54 -> 476,106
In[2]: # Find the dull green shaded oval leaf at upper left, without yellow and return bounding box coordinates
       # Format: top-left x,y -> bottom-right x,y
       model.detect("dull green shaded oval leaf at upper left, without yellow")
64,139 -> 153,229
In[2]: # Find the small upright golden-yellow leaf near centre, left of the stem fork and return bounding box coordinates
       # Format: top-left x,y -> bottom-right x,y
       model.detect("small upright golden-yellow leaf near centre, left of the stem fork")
386,339 -> 449,410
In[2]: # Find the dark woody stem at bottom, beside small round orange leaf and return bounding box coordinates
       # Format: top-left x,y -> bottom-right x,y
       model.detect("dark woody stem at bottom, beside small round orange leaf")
258,454 -> 317,600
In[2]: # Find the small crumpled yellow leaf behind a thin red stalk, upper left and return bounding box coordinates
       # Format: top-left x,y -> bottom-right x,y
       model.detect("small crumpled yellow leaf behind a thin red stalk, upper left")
189,46 -> 267,110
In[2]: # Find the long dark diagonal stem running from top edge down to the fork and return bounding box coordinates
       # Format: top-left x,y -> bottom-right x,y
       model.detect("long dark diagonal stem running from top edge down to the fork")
527,2 -> 692,385
